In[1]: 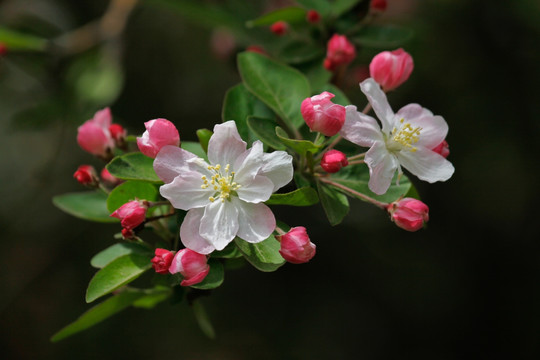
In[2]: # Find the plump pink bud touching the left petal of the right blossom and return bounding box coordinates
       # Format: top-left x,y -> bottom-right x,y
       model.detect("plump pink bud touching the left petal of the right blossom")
300,91 -> 346,136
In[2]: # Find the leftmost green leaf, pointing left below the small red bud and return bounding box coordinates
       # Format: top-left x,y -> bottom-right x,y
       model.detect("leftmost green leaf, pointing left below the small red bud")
53,191 -> 119,223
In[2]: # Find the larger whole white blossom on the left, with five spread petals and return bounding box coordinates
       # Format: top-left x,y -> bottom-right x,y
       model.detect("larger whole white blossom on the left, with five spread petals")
154,121 -> 293,254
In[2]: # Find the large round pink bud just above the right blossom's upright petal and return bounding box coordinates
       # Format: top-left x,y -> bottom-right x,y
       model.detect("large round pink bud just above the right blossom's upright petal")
369,48 -> 414,91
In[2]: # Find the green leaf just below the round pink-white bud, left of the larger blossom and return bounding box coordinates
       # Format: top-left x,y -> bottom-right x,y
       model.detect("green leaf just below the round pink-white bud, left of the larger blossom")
107,152 -> 161,183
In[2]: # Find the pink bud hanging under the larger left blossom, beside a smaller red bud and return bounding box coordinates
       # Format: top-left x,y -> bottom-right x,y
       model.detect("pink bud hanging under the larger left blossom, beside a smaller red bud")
169,249 -> 210,286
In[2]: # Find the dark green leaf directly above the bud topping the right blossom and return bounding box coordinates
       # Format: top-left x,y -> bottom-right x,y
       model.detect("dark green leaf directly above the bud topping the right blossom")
351,25 -> 413,48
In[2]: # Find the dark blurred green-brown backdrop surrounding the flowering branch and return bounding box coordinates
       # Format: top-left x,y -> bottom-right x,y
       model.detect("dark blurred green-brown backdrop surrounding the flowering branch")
0,0 -> 540,360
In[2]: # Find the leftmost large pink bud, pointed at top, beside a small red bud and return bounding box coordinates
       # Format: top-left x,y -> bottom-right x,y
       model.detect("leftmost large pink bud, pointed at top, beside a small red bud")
77,108 -> 114,158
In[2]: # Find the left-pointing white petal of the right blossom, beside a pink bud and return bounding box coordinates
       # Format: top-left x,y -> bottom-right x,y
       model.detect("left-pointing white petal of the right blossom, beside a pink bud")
339,105 -> 383,147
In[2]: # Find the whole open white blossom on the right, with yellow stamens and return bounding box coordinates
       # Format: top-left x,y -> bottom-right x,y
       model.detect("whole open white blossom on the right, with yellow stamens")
340,78 -> 454,195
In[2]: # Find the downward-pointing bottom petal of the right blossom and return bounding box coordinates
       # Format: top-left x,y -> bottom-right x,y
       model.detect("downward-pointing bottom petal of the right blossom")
366,142 -> 399,195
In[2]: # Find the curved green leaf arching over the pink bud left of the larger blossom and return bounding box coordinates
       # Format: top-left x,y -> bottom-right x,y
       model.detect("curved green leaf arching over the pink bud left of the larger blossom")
107,180 -> 158,213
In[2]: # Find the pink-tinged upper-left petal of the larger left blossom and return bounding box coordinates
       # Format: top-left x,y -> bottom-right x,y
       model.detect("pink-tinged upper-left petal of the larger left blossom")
154,145 -> 197,183
